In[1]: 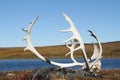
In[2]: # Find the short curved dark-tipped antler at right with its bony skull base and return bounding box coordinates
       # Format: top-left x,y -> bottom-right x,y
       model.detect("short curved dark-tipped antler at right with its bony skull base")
82,30 -> 102,72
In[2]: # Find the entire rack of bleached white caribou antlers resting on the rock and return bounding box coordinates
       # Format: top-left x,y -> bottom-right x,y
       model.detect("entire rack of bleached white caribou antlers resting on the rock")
22,13 -> 102,70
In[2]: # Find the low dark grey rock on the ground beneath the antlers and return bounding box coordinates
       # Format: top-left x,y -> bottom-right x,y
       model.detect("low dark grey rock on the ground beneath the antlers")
30,68 -> 99,80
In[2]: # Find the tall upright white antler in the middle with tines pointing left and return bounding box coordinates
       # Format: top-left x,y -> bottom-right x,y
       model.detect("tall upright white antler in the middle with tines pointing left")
60,13 -> 90,70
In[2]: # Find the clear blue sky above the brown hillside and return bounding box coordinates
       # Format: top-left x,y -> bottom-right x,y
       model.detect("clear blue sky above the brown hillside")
0,0 -> 120,47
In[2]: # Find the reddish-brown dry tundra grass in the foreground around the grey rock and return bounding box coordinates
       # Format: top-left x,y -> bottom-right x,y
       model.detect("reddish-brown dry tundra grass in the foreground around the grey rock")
0,70 -> 120,80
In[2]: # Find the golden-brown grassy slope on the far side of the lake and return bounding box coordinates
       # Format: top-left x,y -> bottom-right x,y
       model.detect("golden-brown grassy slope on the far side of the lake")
0,41 -> 120,59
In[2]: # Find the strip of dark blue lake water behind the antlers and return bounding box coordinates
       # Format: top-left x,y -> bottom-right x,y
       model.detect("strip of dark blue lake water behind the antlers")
0,59 -> 120,71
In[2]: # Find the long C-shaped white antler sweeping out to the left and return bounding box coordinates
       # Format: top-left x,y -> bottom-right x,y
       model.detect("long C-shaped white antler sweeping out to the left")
23,17 -> 83,68
